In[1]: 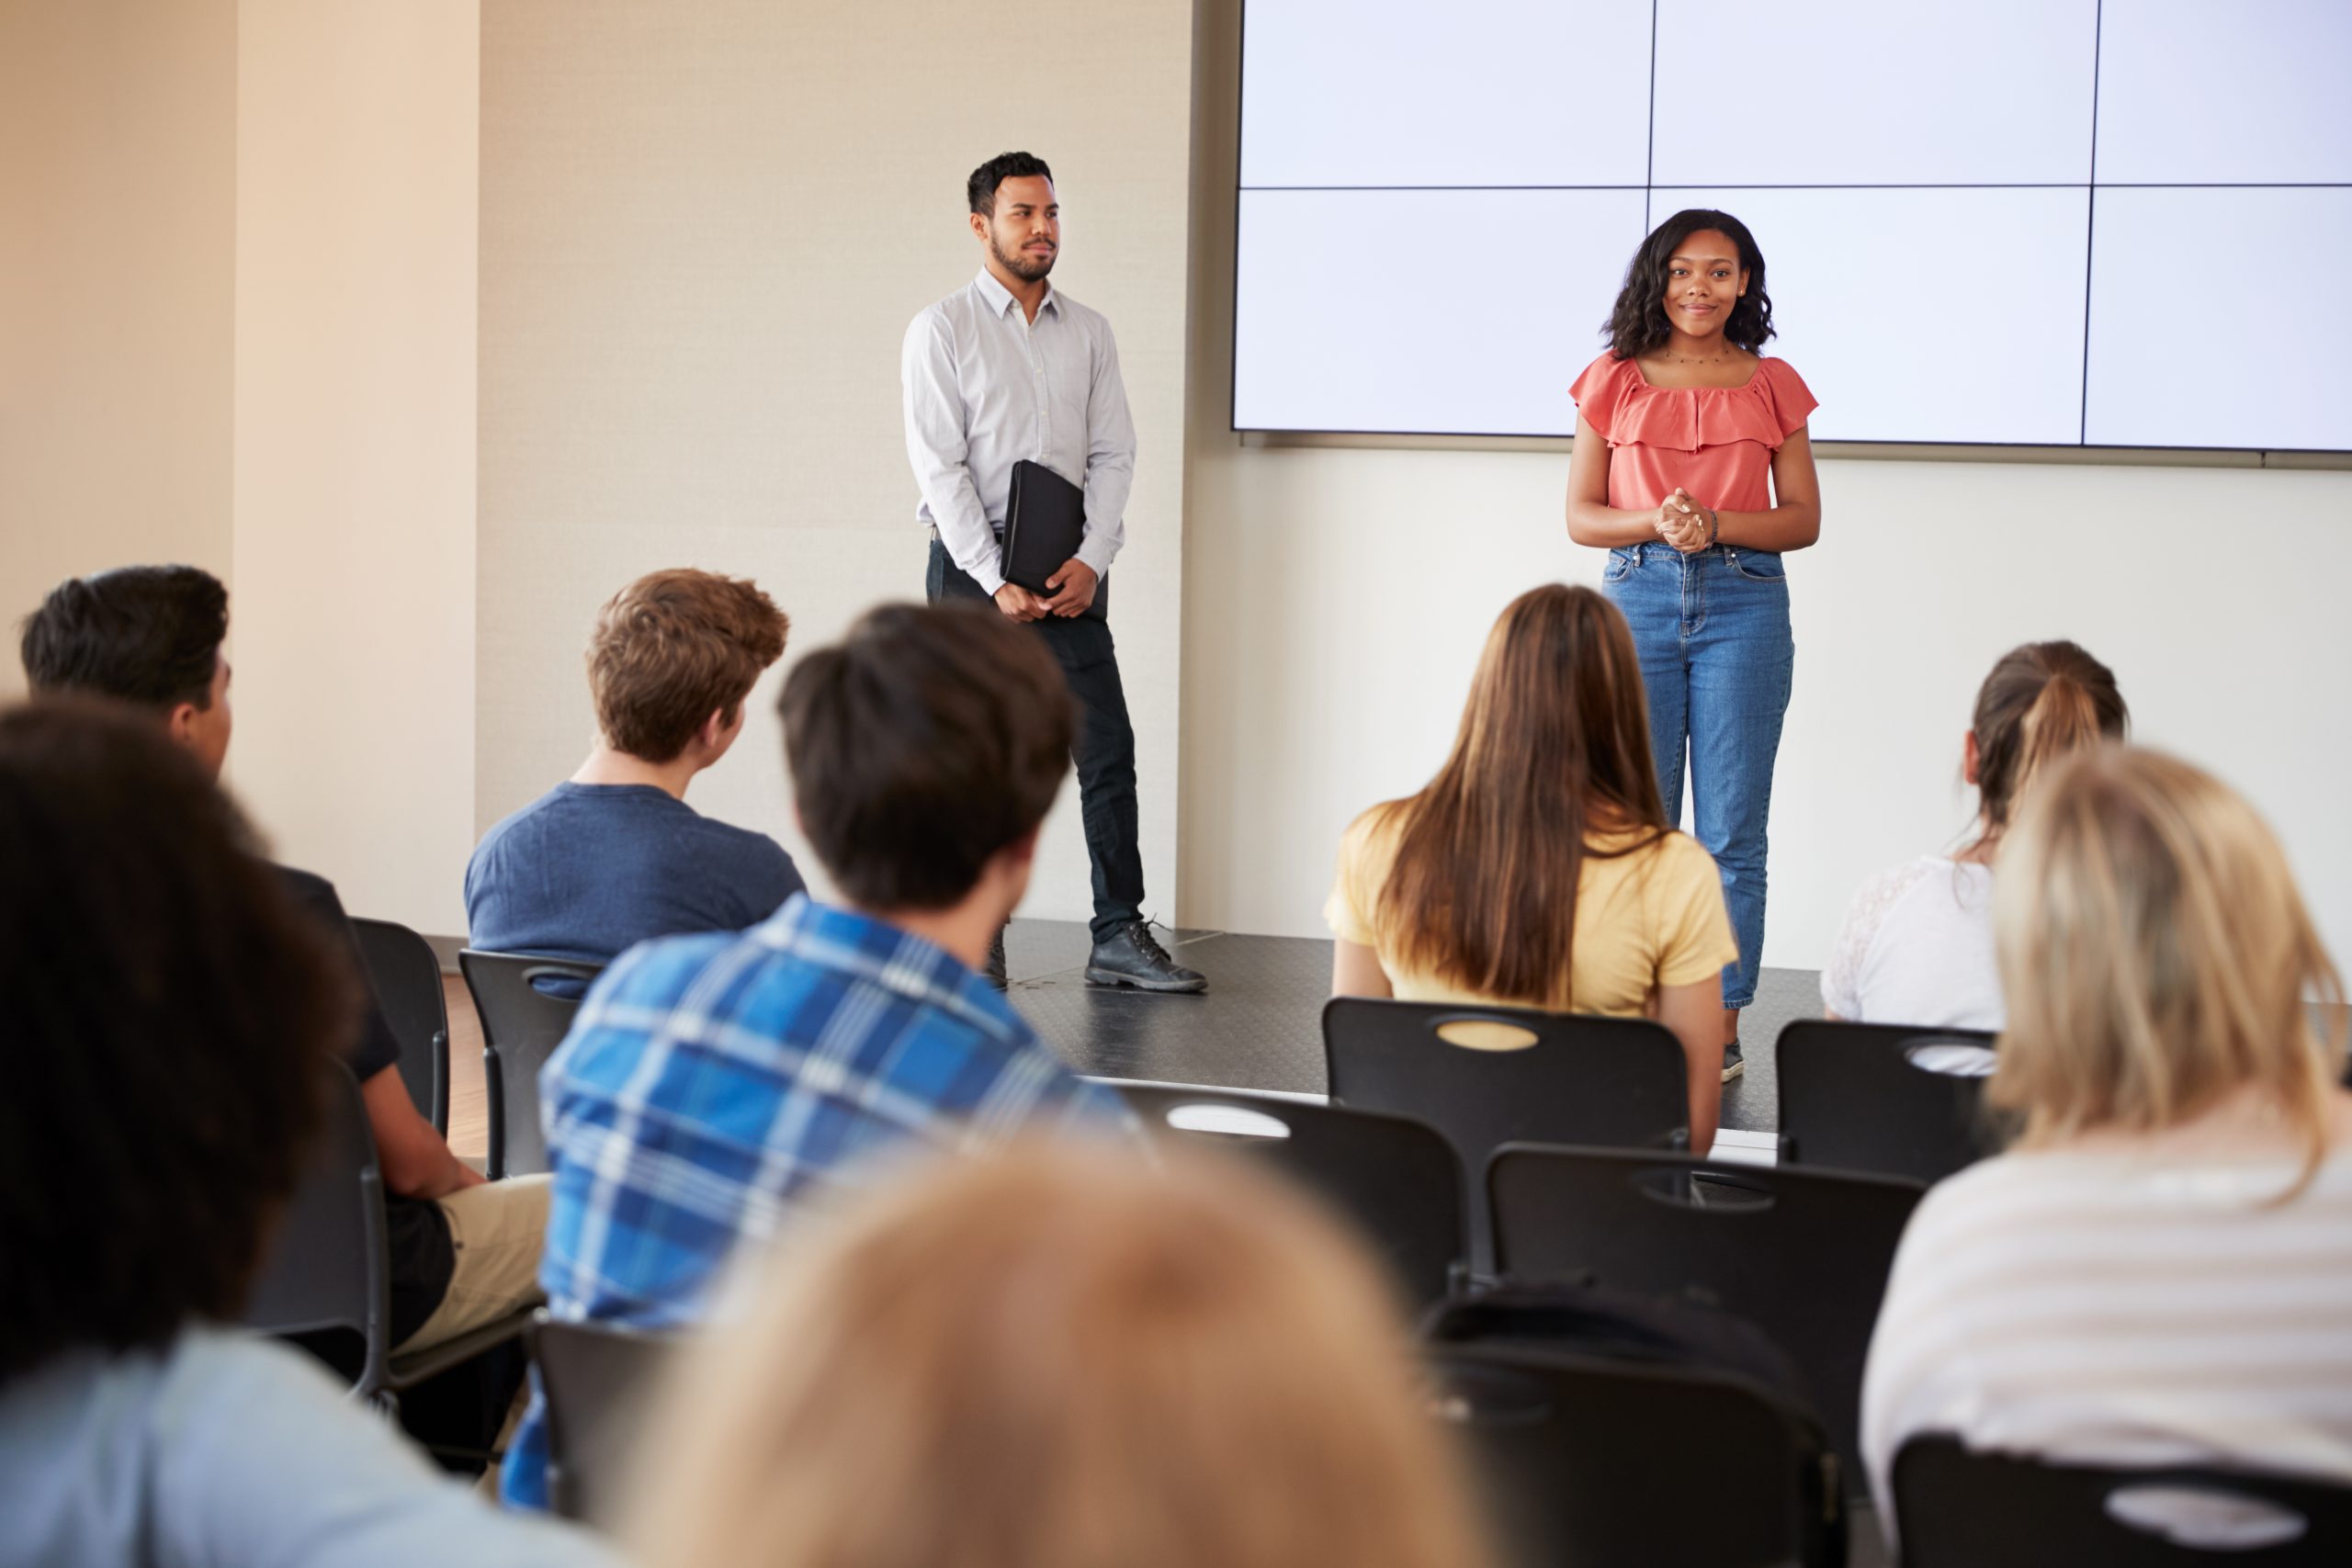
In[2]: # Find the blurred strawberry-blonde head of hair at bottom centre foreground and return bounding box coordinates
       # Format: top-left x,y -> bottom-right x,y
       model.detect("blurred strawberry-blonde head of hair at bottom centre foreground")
626,1145 -> 1484,1568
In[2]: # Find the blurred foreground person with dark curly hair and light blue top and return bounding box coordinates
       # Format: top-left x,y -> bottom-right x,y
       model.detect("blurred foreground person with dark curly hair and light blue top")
0,701 -> 612,1568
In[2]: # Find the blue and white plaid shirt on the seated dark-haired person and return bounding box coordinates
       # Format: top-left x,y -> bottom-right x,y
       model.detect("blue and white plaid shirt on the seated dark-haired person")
499,894 -> 1141,1509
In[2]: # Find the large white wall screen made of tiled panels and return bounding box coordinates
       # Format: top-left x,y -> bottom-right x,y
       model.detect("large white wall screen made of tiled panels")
1232,0 -> 2352,451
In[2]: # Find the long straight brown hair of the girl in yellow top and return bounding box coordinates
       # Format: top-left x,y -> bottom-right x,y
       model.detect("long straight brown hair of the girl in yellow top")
1374,583 -> 1672,1010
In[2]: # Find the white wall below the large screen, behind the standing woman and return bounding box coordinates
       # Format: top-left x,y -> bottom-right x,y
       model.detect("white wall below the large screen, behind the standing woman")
1181,0 -> 2352,968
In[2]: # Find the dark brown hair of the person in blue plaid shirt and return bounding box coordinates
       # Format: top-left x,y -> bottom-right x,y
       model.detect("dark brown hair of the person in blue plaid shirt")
776,604 -> 1077,909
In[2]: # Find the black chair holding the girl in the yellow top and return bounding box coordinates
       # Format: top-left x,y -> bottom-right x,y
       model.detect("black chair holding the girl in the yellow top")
1322,997 -> 1691,1274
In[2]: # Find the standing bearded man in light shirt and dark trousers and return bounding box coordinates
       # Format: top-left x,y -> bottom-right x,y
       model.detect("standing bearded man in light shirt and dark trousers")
899,152 -> 1209,992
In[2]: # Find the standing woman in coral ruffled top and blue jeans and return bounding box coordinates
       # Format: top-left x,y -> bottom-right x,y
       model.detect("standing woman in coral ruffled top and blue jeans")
1569,209 -> 1820,1081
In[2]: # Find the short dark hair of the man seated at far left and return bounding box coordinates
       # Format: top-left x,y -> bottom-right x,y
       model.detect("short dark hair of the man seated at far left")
21,567 -> 228,707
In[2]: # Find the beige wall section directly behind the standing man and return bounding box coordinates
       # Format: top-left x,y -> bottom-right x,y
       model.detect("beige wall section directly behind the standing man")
475,0 -> 1193,917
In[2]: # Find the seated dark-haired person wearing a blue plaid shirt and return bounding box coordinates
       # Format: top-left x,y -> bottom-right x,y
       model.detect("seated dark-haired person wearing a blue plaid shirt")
501,604 -> 1141,1506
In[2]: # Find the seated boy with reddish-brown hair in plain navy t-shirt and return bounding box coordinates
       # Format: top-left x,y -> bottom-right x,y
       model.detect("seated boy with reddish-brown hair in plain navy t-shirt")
466,569 -> 802,995
